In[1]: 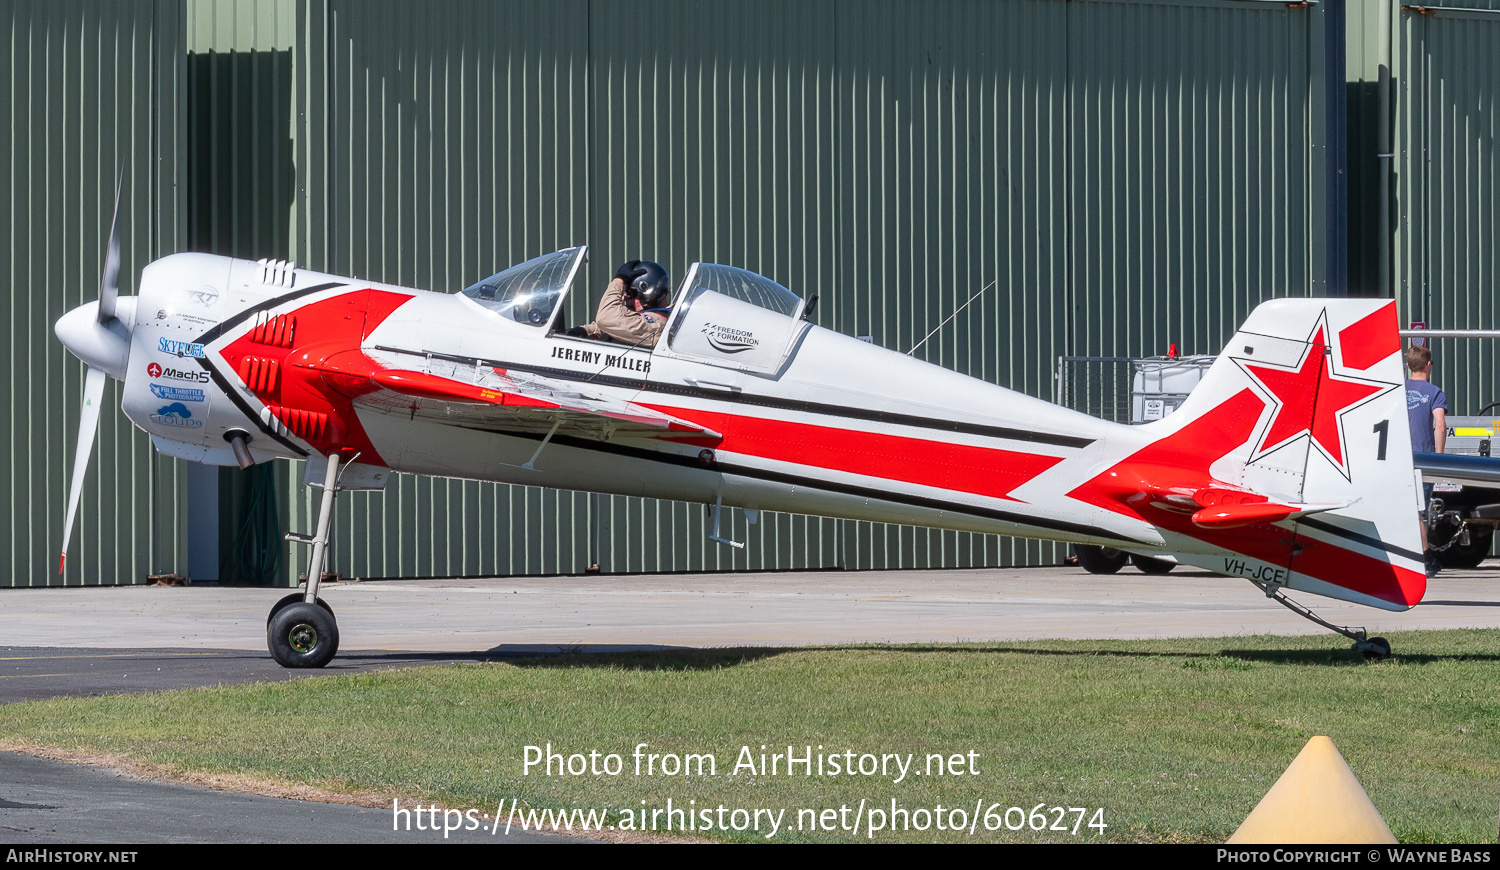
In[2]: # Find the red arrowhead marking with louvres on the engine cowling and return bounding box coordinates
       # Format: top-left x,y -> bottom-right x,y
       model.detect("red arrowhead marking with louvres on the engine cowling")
221,290 -> 413,465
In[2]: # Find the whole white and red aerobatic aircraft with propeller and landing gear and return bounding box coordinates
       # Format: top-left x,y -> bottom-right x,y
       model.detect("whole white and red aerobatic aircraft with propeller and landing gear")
57,231 -> 1427,668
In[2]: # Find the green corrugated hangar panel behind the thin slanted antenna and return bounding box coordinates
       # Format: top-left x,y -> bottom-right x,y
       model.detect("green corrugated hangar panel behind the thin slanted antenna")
821,0 -> 1071,569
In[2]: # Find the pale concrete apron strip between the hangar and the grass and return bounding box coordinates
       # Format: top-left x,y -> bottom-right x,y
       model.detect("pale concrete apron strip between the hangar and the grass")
0,560 -> 1500,660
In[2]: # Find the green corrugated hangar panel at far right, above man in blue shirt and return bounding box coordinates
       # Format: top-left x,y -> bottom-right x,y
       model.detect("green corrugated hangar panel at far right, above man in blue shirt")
1391,0 -> 1500,414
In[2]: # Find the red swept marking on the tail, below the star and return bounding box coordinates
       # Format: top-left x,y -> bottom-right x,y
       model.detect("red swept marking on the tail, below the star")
1068,389 -> 1427,606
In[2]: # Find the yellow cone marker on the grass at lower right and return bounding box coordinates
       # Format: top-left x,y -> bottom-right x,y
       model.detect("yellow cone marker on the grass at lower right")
1229,737 -> 1397,843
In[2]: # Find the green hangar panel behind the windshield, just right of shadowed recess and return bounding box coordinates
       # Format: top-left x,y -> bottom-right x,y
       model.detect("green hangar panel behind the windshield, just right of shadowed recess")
290,2 -> 599,576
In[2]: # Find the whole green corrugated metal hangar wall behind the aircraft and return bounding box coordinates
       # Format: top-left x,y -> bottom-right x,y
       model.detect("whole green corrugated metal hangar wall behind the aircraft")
0,0 -> 1500,585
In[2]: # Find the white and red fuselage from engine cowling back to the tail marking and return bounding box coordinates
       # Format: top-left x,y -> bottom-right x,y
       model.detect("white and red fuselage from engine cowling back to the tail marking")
125,254 -> 1161,548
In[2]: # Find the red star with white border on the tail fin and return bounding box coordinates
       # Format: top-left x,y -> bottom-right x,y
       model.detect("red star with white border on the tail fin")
1241,318 -> 1389,477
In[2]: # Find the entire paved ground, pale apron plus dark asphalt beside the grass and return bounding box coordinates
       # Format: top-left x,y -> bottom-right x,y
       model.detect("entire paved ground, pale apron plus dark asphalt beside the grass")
0,561 -> 1500,843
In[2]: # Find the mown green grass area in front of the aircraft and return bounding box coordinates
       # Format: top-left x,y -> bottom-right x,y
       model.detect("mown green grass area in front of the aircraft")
0,630 -> 1500,843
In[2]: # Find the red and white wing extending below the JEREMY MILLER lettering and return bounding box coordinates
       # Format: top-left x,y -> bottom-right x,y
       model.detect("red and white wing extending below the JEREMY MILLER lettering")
320,351 -> 722,444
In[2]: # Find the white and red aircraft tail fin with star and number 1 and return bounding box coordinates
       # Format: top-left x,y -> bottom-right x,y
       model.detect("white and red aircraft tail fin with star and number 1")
1074,299 -> 1427,611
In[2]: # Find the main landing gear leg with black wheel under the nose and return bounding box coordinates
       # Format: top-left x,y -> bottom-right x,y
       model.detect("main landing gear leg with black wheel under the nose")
266,453 -> 339,668
